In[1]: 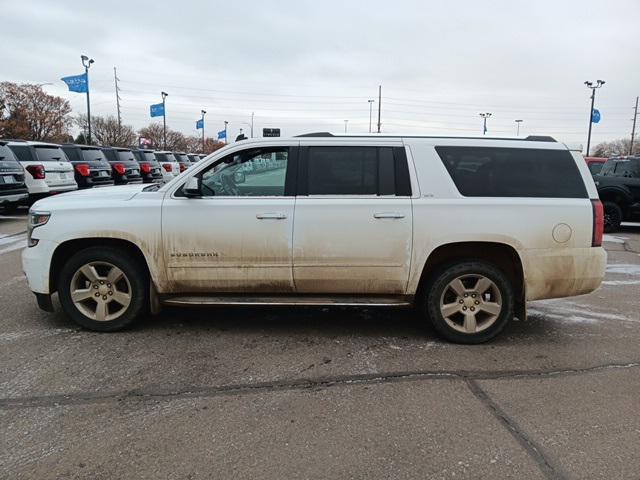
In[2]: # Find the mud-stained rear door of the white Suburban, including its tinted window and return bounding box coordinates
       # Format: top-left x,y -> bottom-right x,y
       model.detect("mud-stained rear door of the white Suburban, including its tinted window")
293,143 -> 412,294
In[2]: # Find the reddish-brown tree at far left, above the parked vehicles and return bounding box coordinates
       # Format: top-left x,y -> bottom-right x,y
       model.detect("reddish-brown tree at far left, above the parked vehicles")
0,82 -> 72,142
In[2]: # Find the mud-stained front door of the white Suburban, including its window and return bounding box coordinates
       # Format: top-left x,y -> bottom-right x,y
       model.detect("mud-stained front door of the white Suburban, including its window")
162,147 -> 297,294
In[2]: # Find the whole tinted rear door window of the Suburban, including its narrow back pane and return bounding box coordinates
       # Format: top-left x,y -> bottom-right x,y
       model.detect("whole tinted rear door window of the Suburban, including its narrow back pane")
300,146 -> 411,196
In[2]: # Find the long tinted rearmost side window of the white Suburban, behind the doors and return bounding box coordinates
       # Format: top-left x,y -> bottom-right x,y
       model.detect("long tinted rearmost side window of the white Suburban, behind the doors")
436,147 -> 588,198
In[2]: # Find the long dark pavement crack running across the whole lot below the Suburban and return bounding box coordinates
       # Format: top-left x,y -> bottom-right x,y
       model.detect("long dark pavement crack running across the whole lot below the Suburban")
0,362 -> 640,410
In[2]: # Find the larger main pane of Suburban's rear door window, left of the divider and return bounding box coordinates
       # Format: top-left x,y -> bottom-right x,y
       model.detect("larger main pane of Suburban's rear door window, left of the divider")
307,147 -> 378,195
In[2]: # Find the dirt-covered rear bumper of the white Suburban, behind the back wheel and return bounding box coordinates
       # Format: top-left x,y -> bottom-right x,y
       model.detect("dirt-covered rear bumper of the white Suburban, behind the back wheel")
520,247 -> 607,301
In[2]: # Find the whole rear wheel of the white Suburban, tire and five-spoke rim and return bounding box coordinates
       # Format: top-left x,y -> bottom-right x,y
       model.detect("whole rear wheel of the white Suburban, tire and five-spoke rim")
424,261 -> 514,344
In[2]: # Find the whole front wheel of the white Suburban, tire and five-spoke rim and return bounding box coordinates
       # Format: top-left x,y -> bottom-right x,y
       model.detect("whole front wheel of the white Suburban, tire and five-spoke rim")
58,247 -> 148,332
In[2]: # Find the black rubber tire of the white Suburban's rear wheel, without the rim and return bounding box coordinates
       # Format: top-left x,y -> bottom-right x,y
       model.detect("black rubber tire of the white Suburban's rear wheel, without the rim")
421,260 -> 514,344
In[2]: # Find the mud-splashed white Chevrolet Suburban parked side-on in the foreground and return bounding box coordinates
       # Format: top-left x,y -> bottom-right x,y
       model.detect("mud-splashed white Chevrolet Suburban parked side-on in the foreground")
23,133 -> 606,343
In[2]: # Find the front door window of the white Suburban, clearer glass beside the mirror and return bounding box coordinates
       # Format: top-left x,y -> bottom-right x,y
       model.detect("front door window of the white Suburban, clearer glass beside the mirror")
202,148 -> 289,197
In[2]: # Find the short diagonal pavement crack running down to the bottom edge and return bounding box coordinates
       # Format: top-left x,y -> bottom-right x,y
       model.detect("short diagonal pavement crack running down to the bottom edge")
465,378 -> 568,480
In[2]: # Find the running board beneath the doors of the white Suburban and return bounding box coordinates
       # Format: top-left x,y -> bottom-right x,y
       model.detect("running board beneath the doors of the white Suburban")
161,295 -> 411,307
